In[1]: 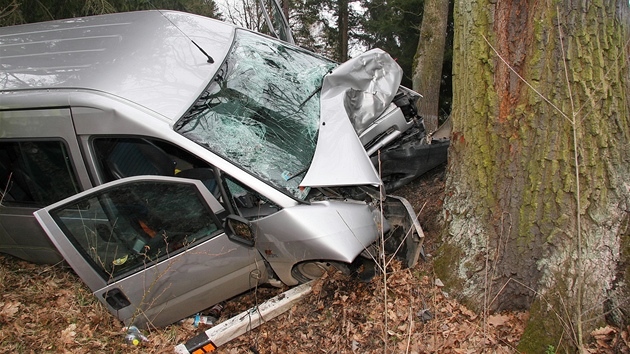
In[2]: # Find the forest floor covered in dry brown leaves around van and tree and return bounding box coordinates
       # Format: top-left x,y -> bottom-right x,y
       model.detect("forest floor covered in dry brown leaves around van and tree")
0,167 -> 628,354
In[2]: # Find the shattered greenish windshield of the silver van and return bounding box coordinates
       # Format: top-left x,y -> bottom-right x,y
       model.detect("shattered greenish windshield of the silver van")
175,30 -> 336,199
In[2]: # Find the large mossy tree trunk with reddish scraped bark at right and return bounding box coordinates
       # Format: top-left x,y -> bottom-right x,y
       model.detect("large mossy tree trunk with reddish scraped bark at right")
436,0 -> 630,353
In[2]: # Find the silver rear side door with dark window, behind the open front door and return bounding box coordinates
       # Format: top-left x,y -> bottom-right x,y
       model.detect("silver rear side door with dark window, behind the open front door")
0,108 -> 91,263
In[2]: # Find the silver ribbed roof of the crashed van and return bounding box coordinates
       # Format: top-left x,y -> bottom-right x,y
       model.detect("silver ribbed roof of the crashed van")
0,10 -> 235,121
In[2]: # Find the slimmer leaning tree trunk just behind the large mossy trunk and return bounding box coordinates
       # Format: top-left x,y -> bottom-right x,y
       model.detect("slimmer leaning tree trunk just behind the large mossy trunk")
412,0 -> 449,133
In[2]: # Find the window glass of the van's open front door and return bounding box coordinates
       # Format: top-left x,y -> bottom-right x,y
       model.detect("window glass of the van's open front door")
51,182 -> 219,281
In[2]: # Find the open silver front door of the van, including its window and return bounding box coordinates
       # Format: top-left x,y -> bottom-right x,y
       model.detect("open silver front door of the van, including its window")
34,176 -> 266,327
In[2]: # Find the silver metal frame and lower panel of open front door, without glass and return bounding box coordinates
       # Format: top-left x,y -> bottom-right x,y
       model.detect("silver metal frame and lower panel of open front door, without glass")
35,176 -> 267,326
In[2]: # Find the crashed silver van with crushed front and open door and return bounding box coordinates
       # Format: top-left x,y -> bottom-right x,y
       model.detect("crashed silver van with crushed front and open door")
0,11 -> 423,326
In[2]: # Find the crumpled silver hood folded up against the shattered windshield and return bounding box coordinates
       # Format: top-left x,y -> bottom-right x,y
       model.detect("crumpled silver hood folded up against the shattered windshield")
300,49 -> 402,191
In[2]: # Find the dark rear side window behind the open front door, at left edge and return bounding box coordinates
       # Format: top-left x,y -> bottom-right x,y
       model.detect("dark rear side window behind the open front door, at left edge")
0,140 -> 79,206
